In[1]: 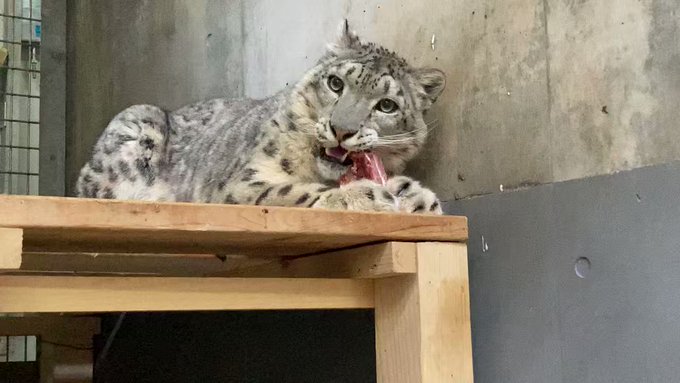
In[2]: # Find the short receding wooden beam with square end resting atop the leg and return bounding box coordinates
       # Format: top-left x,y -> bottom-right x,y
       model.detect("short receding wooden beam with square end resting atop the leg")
215,242 -> 416,279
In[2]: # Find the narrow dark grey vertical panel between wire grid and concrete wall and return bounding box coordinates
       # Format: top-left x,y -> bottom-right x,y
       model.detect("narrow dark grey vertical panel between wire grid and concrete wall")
39,0 -> 66,196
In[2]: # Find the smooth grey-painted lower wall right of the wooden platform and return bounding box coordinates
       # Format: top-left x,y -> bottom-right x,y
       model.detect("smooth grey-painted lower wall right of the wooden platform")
446,163 -> 680,383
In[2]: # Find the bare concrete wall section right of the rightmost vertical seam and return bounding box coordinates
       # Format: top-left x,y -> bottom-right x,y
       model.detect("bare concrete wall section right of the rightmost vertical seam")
548,0 -> 680,180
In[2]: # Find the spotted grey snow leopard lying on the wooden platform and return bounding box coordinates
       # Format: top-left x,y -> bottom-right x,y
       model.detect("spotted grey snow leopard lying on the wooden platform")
76,20 -> 446,215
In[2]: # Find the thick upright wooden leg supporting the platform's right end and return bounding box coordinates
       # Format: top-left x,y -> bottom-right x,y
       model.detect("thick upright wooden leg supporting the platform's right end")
375,243 -> 473,383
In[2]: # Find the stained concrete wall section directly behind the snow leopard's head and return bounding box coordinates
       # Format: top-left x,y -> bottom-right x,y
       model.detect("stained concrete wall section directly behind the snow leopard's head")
238,0 -> 552,199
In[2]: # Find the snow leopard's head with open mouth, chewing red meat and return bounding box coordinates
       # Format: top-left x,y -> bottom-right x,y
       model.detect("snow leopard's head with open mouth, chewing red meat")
291,20 -> 446,180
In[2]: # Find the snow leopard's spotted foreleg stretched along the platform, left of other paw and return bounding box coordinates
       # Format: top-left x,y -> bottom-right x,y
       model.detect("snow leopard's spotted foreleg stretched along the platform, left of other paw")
224,180 -> 398,212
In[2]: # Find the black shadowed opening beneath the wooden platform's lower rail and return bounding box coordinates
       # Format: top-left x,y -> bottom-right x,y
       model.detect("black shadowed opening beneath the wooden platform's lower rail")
95,310 -> 375,383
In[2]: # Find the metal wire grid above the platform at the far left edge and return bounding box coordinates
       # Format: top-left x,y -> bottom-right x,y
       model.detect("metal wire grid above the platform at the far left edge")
0,0 -> 42,194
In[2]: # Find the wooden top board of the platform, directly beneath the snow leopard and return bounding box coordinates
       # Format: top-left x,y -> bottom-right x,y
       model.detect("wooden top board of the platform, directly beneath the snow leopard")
0,196 -> 467,256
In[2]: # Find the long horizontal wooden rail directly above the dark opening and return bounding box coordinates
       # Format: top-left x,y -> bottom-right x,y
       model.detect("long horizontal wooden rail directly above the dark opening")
0,276 -> 374,313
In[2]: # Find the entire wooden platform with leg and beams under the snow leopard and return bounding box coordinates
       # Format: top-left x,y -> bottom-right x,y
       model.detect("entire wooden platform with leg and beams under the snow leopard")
0,196 -> 472,383
